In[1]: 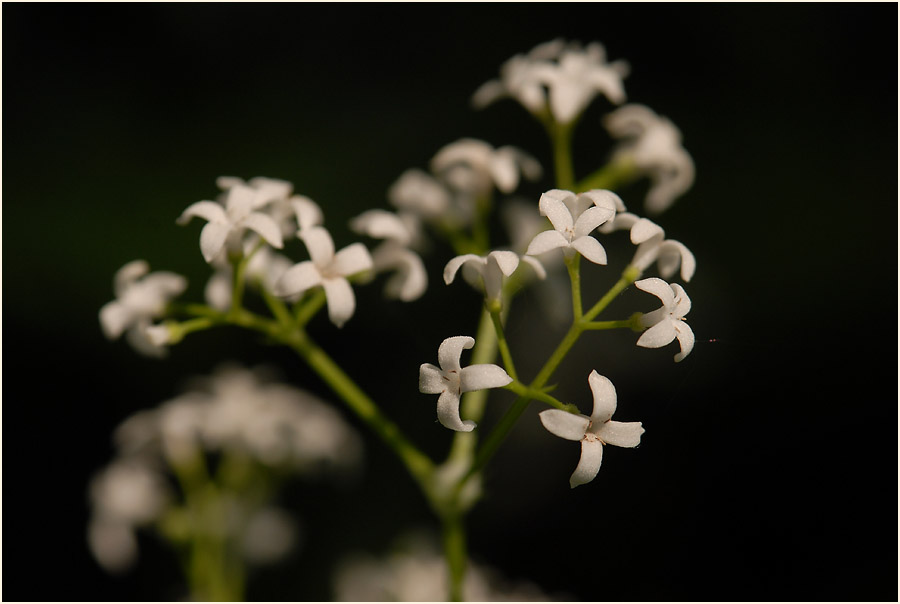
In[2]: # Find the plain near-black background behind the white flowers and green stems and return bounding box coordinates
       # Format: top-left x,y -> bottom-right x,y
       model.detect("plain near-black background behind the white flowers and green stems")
3,3 -> 897,601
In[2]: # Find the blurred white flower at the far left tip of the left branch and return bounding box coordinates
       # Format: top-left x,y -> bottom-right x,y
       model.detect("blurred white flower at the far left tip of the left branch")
100,260 -> 187,356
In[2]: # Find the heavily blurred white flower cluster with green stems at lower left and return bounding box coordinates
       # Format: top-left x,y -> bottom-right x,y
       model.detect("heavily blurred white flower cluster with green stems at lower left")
88,366 -> 362,571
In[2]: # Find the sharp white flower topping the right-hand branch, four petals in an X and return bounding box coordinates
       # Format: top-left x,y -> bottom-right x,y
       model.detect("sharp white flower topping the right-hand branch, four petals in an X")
525,189 -> 617,264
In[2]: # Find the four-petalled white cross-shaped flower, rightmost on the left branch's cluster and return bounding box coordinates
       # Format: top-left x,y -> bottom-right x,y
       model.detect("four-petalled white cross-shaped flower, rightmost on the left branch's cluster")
275,226 -> 372,327
